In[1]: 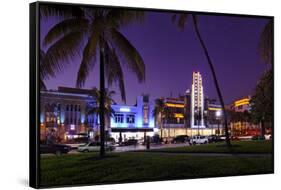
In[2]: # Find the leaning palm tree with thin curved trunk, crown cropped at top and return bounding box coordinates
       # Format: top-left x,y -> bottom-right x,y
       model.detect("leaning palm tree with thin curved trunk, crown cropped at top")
172,14 -> 231,147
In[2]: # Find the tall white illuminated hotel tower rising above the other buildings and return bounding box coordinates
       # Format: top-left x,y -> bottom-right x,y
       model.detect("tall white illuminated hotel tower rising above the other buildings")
190,72 -> 205,128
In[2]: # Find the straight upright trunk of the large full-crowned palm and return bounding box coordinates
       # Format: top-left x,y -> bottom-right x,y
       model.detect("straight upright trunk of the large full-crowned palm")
99,37 -> 105,157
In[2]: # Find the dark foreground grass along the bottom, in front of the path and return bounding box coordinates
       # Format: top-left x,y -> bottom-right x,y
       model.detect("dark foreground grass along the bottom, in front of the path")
41,152 -> 273,187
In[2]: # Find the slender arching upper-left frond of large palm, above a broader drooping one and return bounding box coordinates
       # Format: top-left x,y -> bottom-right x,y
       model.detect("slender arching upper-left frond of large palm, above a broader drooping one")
43,18 -> 89,46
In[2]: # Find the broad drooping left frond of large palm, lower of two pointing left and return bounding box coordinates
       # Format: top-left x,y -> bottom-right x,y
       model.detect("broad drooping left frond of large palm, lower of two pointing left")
44,32 -> 83,73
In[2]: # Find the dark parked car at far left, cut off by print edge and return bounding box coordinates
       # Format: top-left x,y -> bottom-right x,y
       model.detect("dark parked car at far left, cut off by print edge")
40,143 -> 71,156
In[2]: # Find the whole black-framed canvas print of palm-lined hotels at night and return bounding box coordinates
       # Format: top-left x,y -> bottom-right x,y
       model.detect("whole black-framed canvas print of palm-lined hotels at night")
30,2 -> 274,188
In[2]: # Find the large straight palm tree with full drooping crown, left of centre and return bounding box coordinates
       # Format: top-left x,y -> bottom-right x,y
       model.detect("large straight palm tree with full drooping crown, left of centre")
43,8 -> 145,157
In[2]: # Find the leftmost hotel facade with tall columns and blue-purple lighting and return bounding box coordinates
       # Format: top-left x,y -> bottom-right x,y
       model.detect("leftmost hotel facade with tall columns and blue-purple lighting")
40,87 -> 97,141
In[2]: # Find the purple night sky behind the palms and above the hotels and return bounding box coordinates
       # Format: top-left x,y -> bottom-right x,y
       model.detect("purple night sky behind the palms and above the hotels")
41,11 -> 267,104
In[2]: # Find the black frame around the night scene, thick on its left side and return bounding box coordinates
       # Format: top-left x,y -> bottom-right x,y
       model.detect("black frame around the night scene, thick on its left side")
29,1 -> 274,188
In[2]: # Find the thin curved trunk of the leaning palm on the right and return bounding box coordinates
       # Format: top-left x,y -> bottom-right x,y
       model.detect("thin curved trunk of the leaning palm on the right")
192,15 -> 231,147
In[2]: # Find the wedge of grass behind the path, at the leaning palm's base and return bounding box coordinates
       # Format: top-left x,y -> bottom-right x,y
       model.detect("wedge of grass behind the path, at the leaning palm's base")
149,140 -> 272,154
